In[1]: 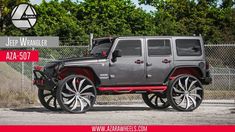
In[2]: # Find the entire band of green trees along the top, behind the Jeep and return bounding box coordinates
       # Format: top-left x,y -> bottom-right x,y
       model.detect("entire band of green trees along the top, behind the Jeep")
0,0 -> 235,45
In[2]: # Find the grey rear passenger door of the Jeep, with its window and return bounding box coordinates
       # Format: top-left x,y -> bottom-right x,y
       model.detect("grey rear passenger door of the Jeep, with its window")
146,38 -> 173,84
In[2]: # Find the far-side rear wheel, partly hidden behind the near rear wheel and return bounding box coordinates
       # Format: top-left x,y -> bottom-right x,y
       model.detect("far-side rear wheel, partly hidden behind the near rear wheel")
142,93 -> 170,109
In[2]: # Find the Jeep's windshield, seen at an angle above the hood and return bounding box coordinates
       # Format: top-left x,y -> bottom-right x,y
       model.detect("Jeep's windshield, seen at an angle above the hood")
91,37 -> 114,57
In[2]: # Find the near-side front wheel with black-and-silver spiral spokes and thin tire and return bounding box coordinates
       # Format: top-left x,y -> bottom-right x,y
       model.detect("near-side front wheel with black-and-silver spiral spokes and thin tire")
57,75 -> 96,113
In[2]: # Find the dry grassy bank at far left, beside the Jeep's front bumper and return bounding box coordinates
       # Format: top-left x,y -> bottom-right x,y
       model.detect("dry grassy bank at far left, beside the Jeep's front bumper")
0,62 -> 37,107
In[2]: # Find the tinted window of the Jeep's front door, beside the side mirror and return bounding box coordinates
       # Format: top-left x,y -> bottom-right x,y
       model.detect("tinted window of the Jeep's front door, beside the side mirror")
116,40 -> 142,56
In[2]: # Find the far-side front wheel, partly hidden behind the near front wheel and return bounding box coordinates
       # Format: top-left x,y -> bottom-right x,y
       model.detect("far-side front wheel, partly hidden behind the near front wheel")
38,89 -> 61,111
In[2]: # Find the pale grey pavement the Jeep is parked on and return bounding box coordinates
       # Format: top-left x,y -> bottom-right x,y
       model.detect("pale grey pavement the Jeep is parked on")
0,103 -> 235,125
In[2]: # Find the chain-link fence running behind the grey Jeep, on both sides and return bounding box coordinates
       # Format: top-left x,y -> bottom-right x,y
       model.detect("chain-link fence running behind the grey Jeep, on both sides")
0,44 -> 235,106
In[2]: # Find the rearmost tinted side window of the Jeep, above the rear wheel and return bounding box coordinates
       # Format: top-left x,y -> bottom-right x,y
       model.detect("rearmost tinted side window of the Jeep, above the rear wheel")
176,39 -> 202,56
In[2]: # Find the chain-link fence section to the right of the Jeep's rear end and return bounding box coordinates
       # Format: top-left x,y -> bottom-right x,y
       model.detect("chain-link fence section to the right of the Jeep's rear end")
205,44 -> 235,102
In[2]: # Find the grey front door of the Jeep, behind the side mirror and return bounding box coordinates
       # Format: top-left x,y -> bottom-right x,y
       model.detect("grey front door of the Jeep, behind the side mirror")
110,38 -> 146,85
